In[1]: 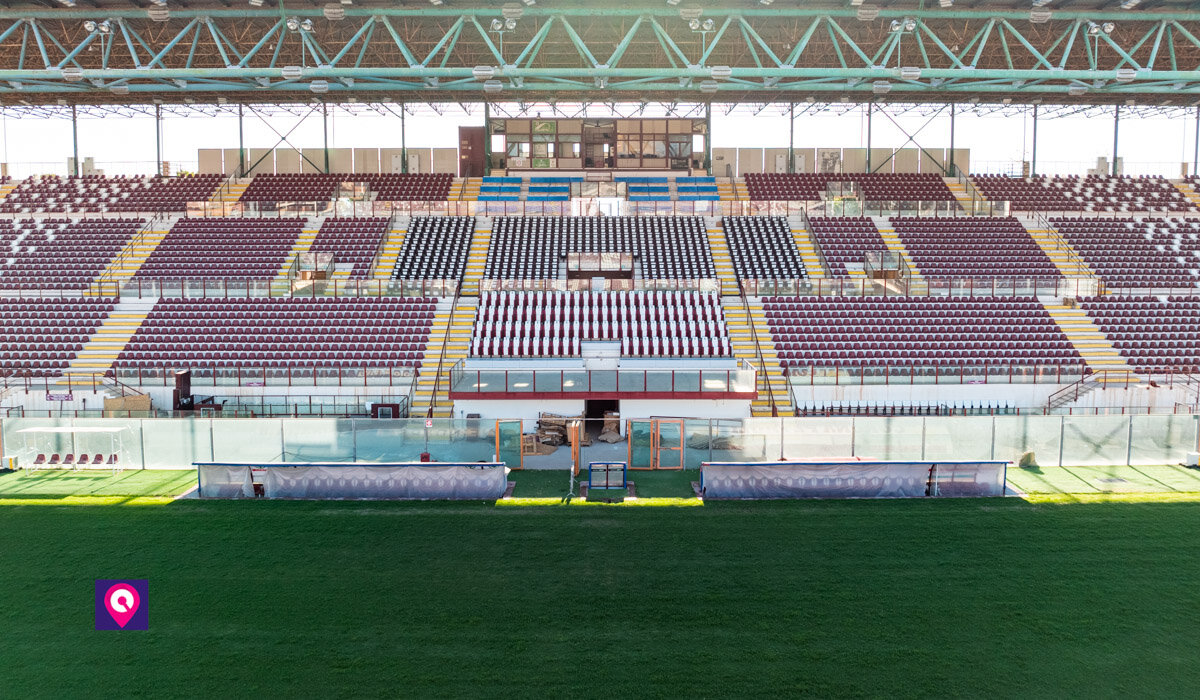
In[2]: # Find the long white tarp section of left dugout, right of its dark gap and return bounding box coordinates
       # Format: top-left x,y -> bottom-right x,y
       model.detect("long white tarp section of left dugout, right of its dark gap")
260,463 -> 508,501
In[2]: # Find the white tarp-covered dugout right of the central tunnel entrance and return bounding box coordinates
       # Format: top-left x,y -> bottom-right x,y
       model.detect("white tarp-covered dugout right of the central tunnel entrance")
701,461 -> 1006,498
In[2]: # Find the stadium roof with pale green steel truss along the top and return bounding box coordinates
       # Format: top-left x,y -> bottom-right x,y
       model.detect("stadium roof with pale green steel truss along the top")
0,0 -> 1200,106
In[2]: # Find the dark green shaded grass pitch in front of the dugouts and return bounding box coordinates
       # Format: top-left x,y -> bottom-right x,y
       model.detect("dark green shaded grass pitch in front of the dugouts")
7,474 -> 1200,698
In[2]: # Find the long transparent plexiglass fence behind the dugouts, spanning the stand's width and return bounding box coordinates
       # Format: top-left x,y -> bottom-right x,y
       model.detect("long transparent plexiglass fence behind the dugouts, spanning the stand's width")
2,415 -> 1196,469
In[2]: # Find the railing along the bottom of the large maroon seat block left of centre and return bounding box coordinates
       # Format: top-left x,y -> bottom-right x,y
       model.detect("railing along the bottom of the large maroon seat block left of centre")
113,365 -> 416,388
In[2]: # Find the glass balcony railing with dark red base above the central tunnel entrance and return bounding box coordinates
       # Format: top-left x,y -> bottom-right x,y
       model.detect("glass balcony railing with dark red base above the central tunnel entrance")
449,360 -> 758,400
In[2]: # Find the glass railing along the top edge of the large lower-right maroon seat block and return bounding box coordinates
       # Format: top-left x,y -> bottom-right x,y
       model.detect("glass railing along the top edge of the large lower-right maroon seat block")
742,277 -> 1099,297
